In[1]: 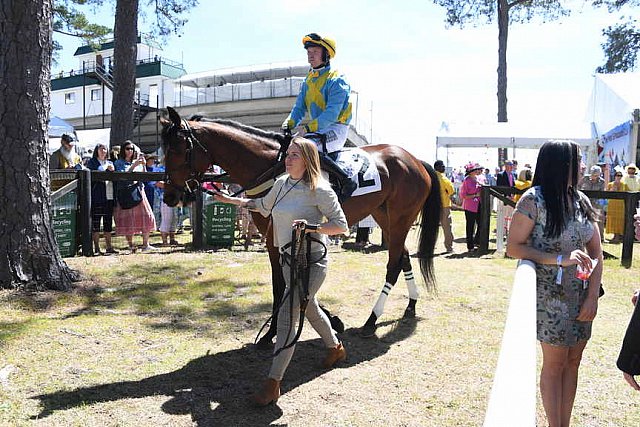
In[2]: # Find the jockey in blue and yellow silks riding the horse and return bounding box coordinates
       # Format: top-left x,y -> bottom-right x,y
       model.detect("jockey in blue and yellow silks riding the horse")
282,33 -> 356,197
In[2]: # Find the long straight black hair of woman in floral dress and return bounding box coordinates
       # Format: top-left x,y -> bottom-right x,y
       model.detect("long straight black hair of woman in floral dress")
533,140 -> 596,237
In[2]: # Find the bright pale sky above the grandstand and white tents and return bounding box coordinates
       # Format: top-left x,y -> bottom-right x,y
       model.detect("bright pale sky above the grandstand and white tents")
54,0 -> 629,167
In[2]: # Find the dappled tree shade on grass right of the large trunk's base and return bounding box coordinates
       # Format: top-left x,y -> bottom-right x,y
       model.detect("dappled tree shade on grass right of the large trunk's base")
3,259 -> 271,336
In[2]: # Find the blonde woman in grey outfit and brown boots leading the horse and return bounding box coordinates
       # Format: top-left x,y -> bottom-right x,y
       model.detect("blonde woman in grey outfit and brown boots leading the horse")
215,138 -> 348,406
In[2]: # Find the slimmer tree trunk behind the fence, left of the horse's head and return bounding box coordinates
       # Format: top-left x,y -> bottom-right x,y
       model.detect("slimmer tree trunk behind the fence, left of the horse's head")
110,0 -> 138,146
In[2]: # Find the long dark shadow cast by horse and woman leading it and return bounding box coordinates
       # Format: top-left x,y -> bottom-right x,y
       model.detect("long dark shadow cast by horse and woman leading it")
31,318 -> 420,426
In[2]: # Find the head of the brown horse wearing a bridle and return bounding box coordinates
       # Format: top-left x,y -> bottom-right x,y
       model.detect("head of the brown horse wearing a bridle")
160,107 -> 210,206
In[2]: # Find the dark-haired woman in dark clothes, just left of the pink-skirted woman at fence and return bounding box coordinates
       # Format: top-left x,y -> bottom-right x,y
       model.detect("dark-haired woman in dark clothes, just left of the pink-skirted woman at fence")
87,144 -> 118,255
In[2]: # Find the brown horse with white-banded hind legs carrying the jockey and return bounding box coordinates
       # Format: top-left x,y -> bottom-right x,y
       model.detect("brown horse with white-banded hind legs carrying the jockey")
162,107 -> 441,345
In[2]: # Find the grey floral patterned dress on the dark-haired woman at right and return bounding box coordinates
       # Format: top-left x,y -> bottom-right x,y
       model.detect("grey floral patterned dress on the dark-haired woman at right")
516,187 -> 594,347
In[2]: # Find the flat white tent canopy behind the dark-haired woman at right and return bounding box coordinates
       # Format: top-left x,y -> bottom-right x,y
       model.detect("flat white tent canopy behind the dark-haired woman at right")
436,121 -> 595,148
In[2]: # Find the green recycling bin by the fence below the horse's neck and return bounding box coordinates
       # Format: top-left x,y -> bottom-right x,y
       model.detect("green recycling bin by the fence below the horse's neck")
203,196 -> 236,248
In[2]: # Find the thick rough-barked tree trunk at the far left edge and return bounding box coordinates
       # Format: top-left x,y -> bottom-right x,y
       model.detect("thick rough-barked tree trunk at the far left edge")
0,0 -> 77,290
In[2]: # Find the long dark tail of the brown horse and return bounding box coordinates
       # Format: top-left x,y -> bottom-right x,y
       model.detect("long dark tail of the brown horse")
418,161 -> 442,291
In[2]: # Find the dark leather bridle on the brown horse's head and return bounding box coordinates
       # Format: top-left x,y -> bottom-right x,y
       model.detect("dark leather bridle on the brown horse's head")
164,119 -> 216,195
